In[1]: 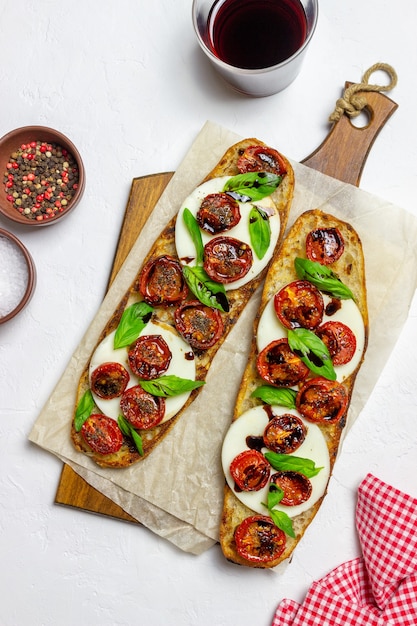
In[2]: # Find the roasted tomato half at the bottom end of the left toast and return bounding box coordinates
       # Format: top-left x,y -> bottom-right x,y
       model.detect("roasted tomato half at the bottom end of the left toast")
80,413 -> 123,456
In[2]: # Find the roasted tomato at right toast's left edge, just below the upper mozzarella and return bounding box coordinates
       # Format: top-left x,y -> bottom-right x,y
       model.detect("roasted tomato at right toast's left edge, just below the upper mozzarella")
256,339 -> 310,387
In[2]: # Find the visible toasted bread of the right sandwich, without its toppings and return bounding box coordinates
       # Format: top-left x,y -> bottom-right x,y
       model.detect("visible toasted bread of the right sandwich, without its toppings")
220,210 -> 368,568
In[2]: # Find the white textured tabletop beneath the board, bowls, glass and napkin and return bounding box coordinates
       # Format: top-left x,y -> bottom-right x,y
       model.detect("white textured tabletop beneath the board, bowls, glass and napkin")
0,0 -> 417,626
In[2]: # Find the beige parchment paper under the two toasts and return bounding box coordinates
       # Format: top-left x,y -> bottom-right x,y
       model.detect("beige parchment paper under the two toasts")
29,122 -> 417,554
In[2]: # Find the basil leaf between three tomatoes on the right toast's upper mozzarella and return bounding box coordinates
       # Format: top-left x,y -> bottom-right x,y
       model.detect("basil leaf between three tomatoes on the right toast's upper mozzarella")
288,328 -> 337,380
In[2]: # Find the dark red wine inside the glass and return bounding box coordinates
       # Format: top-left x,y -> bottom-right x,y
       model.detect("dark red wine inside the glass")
208,0 -> 307,69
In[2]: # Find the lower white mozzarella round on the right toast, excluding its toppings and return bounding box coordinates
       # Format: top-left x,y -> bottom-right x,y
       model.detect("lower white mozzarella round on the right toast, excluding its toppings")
222,406 -> 330,517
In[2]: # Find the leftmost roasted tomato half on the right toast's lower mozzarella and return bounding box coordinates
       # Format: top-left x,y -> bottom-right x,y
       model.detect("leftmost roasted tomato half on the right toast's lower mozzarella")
230,450 -> 270,491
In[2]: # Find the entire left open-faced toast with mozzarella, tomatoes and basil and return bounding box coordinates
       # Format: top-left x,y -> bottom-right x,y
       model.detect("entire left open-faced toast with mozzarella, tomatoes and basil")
71,139 -> 294,468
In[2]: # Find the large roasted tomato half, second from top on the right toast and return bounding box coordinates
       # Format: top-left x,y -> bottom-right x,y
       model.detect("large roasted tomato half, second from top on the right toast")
274,280 -> 324,330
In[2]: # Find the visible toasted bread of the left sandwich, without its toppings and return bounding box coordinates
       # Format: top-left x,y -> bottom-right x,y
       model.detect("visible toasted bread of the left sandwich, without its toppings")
71,138 -> 294,468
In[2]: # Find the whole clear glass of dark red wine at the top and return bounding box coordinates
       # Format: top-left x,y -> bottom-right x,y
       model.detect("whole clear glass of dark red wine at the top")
192,0 -> 318,97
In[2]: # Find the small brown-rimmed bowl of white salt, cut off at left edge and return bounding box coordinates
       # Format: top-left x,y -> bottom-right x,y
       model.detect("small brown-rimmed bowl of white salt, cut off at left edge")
0,228 -> 36,324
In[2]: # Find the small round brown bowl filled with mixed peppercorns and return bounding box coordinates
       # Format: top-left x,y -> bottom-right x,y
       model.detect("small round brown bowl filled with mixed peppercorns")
0,126 -> 85,227
